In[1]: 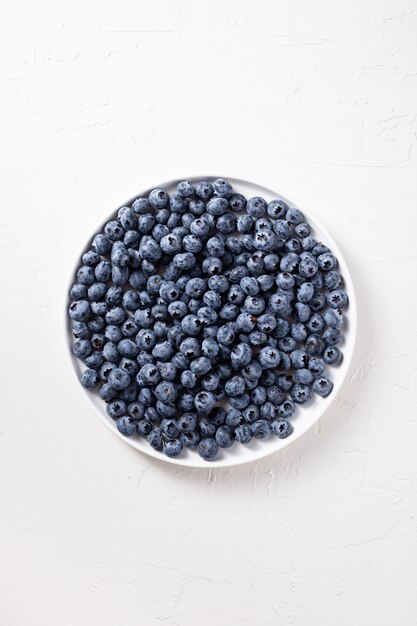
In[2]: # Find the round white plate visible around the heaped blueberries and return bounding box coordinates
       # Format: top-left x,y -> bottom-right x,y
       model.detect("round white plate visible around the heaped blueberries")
65,176 -> 357,468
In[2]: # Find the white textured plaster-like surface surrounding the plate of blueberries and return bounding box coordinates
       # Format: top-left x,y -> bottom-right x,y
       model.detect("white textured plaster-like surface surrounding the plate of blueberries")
0,0 -> 417,626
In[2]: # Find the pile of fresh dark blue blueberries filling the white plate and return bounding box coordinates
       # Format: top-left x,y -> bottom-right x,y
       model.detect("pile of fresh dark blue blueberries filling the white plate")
68,179 -> 348,460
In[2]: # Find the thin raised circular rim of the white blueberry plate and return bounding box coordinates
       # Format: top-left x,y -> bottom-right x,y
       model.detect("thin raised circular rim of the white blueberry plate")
64,175 -> 358,469
